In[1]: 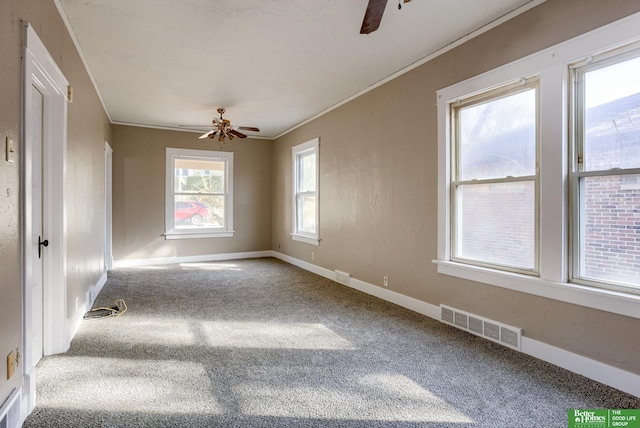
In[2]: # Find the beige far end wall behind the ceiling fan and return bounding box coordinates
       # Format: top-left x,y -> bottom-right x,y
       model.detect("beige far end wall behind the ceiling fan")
113,126 -> 272,260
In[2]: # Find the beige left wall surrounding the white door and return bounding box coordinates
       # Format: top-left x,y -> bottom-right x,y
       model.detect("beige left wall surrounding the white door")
0,0 -> 111,403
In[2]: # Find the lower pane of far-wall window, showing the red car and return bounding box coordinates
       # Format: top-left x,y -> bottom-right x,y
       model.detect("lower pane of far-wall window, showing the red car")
174,195 -> 225,229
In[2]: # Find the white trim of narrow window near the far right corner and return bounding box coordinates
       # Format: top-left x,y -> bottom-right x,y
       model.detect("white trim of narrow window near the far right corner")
291,138 -> 320,245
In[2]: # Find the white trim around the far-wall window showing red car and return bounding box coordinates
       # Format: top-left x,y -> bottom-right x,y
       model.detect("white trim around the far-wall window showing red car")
164,147 -> 234,239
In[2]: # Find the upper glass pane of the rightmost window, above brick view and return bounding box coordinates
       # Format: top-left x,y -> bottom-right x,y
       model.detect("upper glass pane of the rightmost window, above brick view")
584,58 -> 640,171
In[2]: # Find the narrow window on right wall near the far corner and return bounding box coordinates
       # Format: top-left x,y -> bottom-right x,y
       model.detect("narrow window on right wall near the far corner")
291,138 -> 319,245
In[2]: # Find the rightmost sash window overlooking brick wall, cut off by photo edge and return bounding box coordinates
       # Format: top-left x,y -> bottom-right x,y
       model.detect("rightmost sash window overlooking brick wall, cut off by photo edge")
572,50 -> 640,291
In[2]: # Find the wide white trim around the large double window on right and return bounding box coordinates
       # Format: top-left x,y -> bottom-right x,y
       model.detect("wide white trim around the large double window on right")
434,10 -> 640,318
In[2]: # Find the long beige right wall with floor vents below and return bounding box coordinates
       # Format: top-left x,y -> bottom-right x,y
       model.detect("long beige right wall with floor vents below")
273,0 -> 640,373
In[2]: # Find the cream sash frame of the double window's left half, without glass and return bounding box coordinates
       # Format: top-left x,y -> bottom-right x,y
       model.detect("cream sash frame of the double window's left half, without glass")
449,80 -> 540,276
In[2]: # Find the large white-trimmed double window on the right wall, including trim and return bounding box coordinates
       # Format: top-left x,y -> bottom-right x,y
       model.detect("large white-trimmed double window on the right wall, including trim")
434,14 -> 640,318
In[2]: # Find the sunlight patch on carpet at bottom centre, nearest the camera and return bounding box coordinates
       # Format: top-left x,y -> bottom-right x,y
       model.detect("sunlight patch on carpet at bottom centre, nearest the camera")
235,372 -> 473,423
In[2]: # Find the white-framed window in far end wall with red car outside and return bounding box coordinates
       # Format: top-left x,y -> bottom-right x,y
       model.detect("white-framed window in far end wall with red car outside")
165,148 -> 233,239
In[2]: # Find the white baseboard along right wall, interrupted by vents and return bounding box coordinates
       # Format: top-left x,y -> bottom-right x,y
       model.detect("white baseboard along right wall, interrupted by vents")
272,251 -> 640,397
